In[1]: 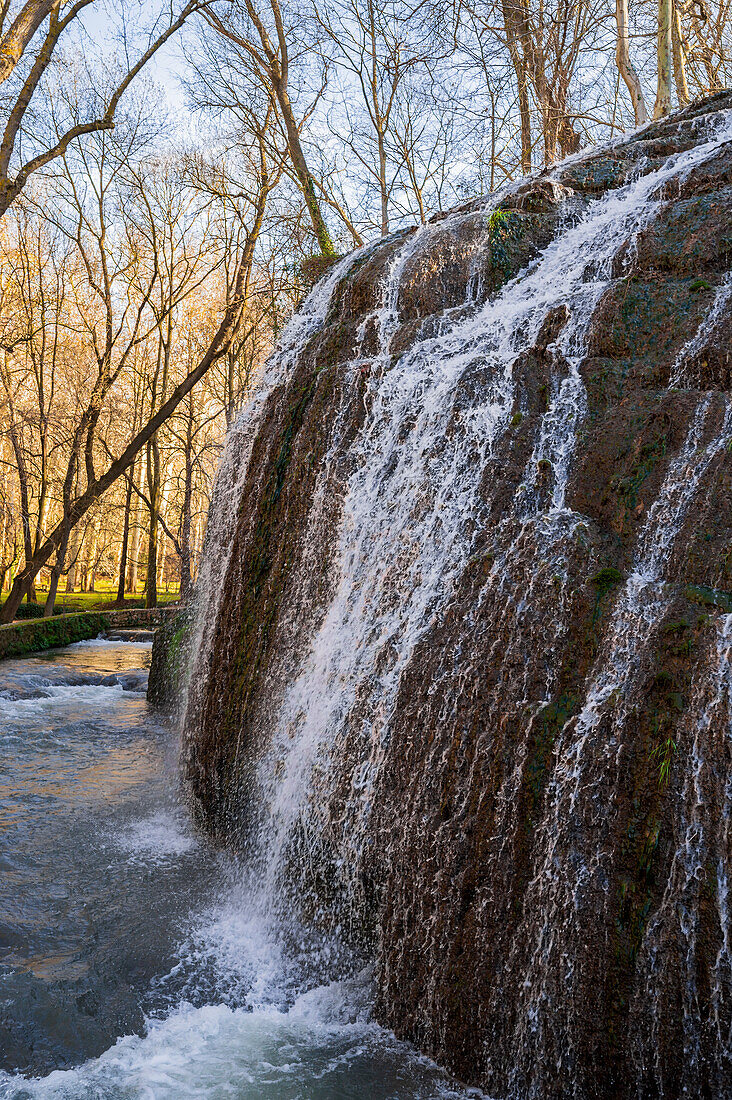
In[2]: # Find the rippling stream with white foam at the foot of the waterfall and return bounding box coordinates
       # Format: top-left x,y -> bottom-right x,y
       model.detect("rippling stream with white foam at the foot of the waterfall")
0,641 -> 473,1100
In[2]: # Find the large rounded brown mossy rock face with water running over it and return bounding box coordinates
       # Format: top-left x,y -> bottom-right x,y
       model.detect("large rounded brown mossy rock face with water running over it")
186,95 -> 732,1100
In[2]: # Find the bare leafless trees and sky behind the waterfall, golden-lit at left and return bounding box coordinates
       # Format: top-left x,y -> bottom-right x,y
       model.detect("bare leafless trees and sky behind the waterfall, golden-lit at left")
0,0 -> 732,622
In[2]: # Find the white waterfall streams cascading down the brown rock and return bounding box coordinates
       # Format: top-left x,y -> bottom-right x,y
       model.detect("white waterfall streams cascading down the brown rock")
186,99 -> 732,1097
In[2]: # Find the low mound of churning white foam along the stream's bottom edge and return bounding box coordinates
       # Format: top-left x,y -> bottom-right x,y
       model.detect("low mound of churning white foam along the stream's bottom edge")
0,987 -> 480,1100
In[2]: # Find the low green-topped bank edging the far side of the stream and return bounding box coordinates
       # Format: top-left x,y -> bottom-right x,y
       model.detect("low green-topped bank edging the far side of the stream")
0,607 -> 178,659
